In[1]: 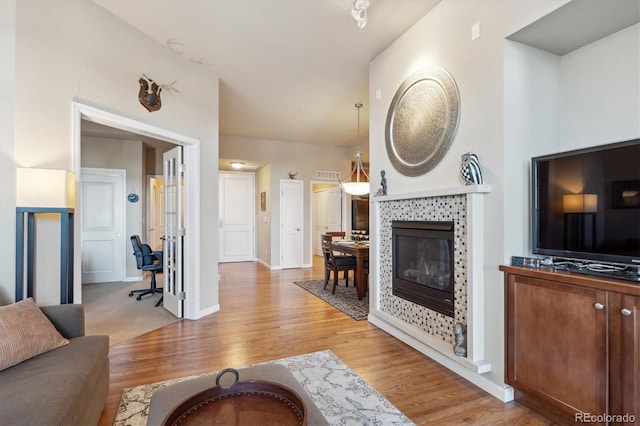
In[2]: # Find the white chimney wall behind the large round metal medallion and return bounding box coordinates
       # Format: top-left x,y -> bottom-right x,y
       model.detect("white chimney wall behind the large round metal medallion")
369,0 -> 564,392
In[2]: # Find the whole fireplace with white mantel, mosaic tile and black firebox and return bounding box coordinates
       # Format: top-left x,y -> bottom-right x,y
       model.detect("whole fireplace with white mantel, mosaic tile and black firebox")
369,185 -> 492,386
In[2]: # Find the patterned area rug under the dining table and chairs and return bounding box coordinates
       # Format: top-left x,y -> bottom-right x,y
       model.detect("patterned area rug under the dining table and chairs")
295,280 -> 369,321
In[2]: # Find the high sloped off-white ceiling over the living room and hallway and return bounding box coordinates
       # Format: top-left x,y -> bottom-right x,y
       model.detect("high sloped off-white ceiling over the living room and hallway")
94,0 -> 439,146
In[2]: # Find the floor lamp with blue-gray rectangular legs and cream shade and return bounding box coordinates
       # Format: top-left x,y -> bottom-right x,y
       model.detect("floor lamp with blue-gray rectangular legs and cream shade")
15,168 -> 76,304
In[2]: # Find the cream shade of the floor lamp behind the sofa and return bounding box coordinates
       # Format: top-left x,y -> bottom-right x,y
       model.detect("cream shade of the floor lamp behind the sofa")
16,167 -> 76,208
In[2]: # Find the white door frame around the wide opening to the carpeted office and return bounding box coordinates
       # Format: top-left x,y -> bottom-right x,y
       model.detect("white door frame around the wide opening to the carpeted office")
71,101 -> 202,319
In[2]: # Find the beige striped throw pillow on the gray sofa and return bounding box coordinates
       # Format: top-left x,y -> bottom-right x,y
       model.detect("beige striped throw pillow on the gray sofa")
0,298 -> 69,371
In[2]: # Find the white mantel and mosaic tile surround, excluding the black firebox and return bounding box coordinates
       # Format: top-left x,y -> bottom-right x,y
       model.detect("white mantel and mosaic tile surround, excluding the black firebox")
369,185 -> 491,374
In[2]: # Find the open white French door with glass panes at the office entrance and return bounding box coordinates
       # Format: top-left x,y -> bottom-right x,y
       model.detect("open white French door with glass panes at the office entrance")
162,146 -> 186,318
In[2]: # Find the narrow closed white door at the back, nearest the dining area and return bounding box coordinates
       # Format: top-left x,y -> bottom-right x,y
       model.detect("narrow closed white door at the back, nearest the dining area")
280,179 -> 304,269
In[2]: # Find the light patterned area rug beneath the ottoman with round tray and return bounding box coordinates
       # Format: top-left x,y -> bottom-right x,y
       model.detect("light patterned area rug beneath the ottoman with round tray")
113,350 -> 413,426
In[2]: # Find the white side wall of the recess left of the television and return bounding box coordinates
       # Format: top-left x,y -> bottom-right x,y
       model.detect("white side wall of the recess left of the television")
504,40 -> 561,261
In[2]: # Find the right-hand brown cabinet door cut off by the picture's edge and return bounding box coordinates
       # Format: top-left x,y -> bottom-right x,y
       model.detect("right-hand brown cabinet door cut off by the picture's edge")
609,293 -> 640,425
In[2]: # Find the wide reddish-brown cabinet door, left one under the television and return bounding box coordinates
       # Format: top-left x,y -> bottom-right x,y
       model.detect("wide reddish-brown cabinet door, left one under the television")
506,274 -> 607,422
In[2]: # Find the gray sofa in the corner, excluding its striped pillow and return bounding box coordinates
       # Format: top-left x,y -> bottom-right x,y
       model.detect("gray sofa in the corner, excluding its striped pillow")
0,305 -> 109,426
